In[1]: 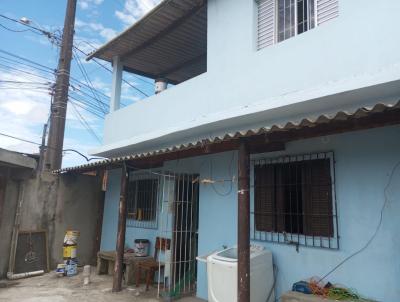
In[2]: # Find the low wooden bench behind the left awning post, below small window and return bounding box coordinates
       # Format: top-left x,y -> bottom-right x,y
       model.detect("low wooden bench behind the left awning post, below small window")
97,251 -> 153,285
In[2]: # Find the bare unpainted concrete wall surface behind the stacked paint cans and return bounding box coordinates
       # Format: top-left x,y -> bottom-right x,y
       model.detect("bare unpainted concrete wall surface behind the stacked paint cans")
0,173 -> 104,278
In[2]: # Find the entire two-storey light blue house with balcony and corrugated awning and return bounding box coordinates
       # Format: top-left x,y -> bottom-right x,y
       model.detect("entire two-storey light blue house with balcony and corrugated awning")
58,0 -> 400,302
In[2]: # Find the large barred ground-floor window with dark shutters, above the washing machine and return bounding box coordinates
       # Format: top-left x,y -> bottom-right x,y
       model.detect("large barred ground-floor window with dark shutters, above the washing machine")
252,152 -> 339,249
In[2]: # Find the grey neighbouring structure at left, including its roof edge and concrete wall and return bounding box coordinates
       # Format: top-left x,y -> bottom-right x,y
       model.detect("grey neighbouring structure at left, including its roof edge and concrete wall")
0,148 -> 104,279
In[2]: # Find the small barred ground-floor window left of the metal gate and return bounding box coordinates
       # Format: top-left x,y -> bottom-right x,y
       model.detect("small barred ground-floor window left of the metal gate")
127,173 -> 159,229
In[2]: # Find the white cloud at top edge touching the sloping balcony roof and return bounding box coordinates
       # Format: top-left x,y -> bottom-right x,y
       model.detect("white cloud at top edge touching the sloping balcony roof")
115,0 -> 161,26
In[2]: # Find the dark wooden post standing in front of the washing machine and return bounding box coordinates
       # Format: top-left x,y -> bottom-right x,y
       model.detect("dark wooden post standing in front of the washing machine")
238,141 -> 250,302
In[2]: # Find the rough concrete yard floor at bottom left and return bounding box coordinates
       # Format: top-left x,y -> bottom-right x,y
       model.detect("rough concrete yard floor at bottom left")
0,272 -> 204,302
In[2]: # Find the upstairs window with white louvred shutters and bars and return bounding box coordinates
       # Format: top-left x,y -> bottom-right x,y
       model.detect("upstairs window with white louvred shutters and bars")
257,0 -> 339,49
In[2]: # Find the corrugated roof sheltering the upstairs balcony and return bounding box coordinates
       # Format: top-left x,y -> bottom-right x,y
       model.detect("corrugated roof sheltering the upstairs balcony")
88,0 -> 207,84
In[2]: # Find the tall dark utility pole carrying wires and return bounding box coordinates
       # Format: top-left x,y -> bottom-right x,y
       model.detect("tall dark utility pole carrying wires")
45,0 -> 76,171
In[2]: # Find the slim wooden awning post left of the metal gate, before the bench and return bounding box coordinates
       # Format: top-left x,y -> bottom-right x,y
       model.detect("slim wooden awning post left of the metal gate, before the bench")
112,162 -> 128,292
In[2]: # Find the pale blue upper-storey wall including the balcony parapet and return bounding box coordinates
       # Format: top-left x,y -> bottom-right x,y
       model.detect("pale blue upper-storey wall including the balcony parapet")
97,0 -> 400,153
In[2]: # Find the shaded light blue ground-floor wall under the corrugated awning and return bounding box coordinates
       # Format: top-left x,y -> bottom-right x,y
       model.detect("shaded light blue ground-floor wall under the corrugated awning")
102,126 -> 400,302
